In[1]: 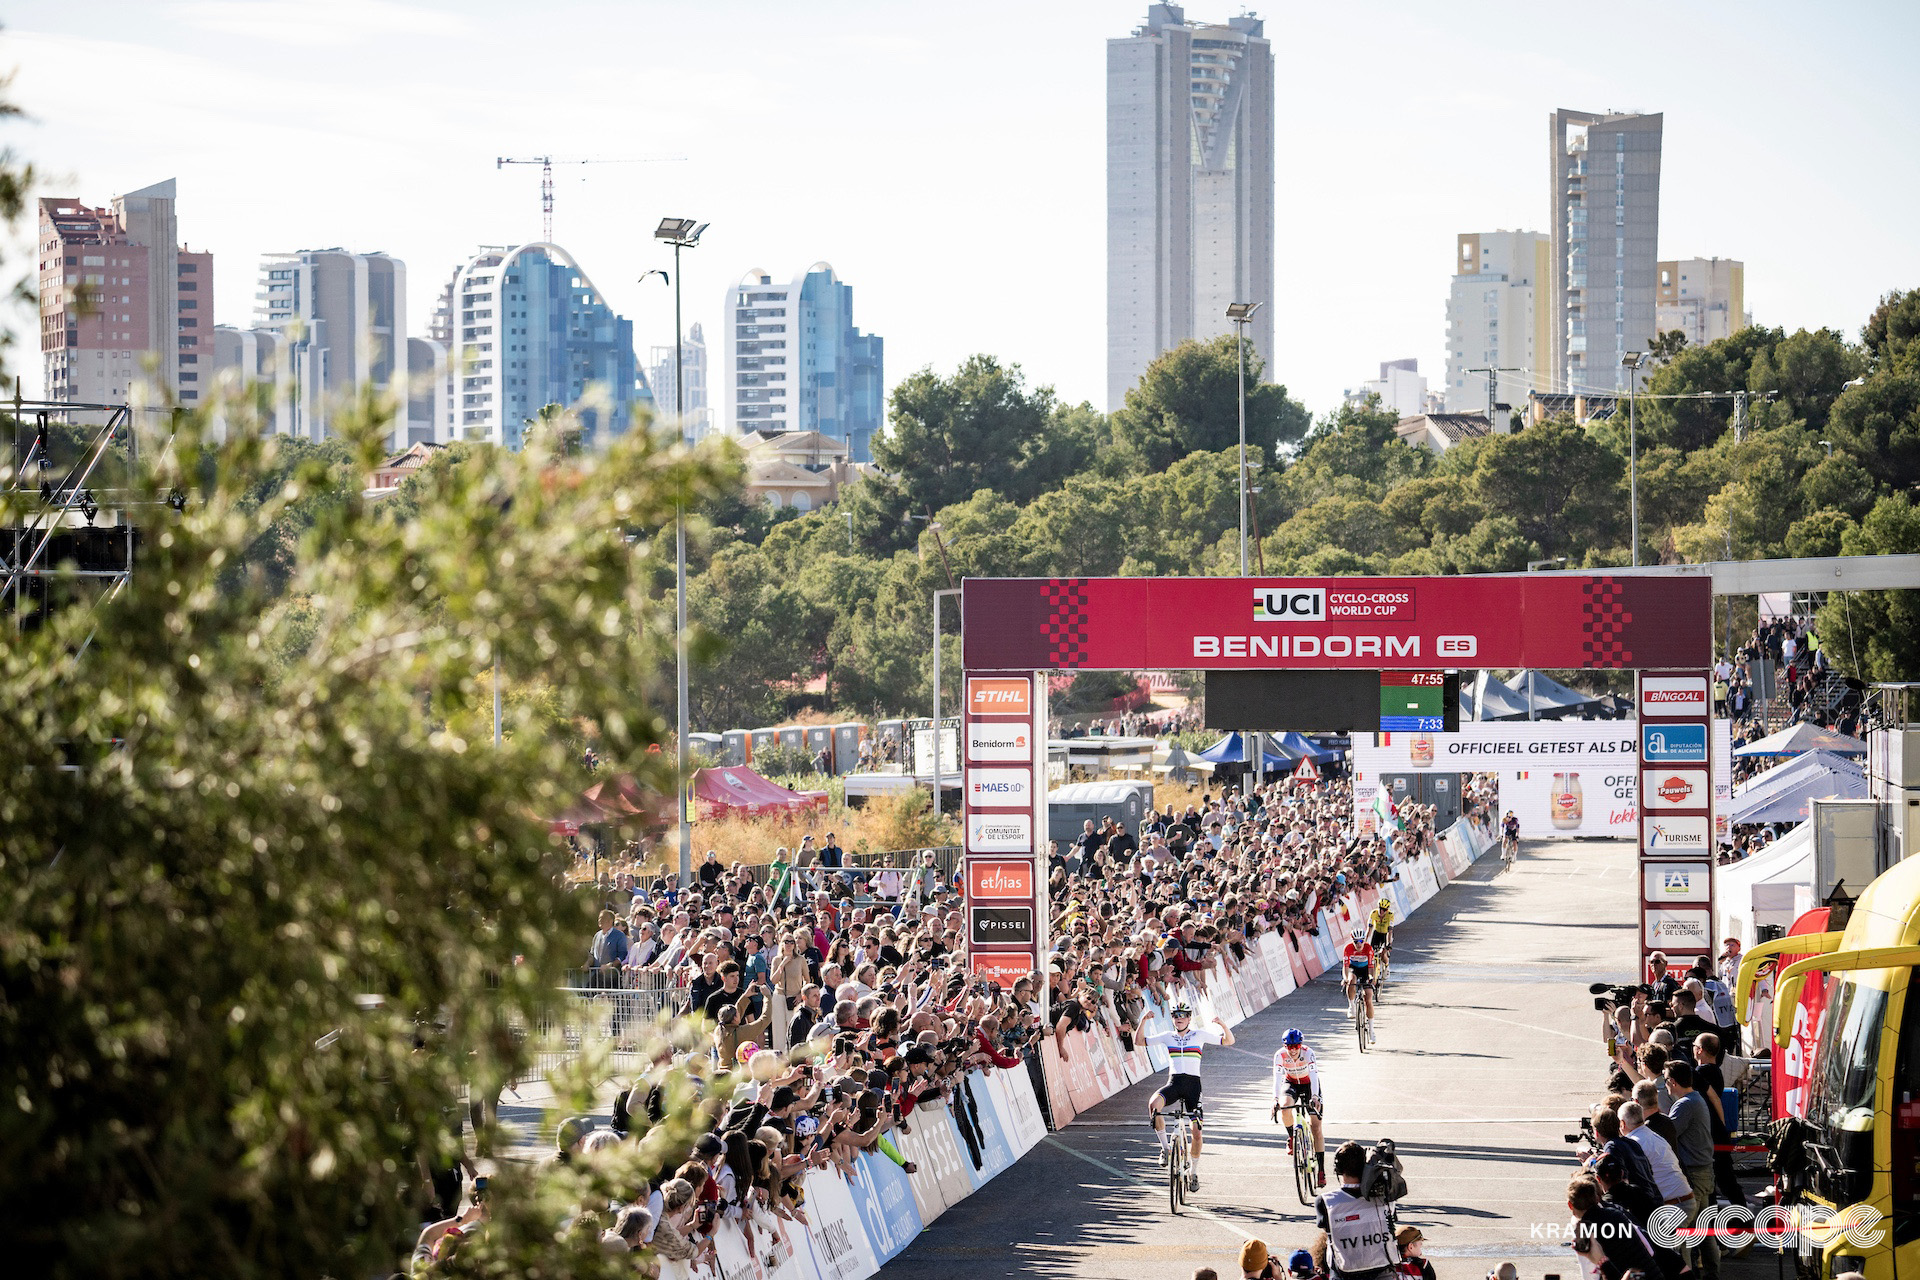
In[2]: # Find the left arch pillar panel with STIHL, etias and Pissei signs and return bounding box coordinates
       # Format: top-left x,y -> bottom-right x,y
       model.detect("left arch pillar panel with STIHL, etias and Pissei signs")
960,670 -> 1046,986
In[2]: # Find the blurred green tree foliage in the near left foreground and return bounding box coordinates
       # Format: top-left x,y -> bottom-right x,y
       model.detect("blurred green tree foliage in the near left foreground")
0,397 -> 722,1278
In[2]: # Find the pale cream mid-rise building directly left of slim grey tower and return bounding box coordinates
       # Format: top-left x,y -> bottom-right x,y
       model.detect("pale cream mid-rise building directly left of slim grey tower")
1446,230 -> 1553,413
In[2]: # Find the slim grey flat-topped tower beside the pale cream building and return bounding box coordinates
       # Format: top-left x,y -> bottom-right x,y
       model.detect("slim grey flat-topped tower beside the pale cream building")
1548,107 -> 1663,391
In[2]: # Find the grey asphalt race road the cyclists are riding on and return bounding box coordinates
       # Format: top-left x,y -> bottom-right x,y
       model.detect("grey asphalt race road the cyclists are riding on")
881,841 -> 1636,1280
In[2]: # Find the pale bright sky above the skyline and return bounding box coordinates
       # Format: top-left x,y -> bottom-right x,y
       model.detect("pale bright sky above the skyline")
0,0 -> 1920,413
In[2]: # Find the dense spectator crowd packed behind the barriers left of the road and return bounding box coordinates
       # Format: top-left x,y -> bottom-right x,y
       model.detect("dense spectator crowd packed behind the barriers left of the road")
417,777 -> 1466,1274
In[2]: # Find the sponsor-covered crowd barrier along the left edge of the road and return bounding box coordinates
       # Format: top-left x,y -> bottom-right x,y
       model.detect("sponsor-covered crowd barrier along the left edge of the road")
660,821 -> 1494,1280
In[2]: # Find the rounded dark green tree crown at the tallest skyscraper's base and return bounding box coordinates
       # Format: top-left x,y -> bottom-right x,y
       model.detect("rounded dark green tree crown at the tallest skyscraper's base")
1114,334 -> 1309,470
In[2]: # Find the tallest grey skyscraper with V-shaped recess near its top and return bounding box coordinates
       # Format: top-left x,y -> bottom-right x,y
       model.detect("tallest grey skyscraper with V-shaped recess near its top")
1106,4 -> 1273,409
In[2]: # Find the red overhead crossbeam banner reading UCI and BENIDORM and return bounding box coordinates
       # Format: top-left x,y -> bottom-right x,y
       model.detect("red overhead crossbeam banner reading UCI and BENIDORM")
964,574 -> 1713,671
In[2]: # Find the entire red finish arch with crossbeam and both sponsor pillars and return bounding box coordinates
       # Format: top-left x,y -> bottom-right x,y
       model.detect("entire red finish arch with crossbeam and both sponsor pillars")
960,572 -> 1715,1000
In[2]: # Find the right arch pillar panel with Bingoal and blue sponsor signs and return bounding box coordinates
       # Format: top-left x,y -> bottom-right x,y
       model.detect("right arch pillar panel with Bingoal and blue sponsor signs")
1636,672 -> 1716,965
